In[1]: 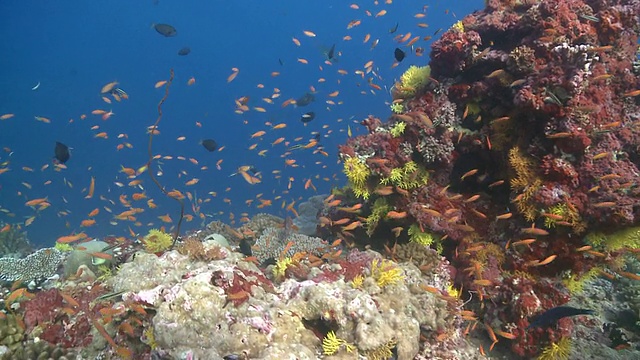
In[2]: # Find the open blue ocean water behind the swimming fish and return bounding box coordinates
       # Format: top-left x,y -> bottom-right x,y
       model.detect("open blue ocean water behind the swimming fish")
0,0 -> 484,246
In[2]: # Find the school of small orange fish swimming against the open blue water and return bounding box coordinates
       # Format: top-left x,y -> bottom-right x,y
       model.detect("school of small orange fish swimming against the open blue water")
0,0 -> 455,242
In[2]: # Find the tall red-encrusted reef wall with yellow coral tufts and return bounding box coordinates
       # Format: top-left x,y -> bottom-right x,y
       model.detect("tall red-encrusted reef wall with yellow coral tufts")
328,0 -> 640,358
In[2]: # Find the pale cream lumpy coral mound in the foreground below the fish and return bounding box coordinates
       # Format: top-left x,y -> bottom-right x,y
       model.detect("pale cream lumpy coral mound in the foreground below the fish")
108,239 -> 476,359
